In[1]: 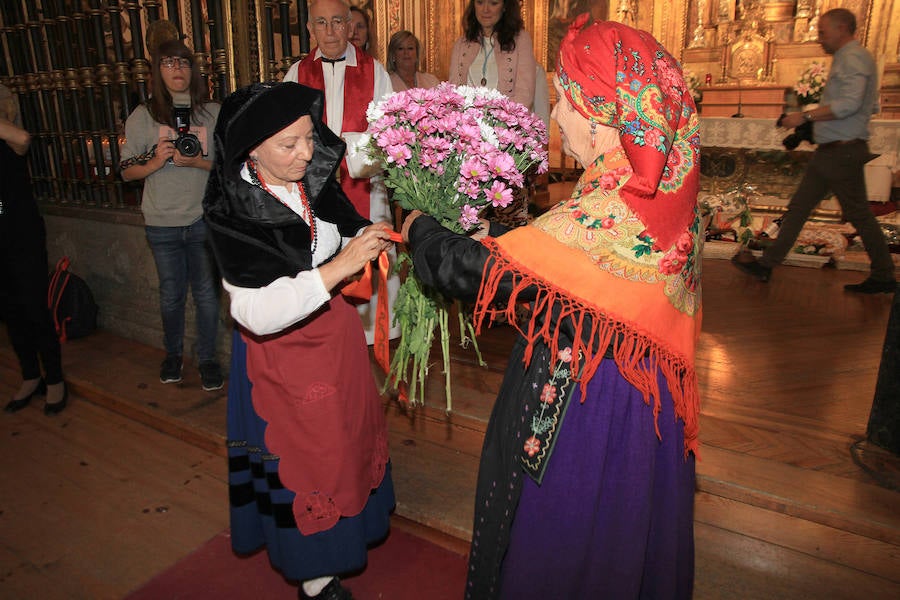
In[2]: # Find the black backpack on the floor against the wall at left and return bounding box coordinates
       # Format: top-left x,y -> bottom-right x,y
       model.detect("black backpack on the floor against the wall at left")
47,256 -> 98,342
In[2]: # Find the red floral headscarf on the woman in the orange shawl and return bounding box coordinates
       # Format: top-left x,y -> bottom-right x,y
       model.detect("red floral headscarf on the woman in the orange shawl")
556,13 -> 700,248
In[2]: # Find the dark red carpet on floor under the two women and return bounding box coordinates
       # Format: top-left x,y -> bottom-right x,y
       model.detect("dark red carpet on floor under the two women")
128,527 -> 466,600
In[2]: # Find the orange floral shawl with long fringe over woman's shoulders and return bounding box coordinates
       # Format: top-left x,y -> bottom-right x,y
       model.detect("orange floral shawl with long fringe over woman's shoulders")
475,166 -> 701,453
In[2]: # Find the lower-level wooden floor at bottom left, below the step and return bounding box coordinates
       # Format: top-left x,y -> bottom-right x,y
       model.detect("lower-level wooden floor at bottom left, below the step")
0,364 -> 228,600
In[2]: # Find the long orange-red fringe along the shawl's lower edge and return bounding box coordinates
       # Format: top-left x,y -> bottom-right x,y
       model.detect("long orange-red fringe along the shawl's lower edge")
473,238 -> 700,457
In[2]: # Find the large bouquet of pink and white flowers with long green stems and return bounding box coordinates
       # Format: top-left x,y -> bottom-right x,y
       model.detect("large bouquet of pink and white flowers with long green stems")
360,83 -> 548,411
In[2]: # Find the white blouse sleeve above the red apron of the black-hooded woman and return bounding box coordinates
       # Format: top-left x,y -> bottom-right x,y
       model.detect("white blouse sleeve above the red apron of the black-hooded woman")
222,269 -> 331,335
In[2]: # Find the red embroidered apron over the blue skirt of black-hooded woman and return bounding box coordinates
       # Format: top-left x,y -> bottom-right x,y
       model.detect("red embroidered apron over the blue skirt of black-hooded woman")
242,295 -> 388,535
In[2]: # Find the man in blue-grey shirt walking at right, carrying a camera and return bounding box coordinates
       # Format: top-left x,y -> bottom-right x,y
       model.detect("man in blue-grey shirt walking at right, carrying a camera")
732,8 -> 897,294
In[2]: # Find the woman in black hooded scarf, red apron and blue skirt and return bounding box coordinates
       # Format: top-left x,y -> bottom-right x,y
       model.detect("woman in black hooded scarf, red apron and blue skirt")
203,83 -> 394,598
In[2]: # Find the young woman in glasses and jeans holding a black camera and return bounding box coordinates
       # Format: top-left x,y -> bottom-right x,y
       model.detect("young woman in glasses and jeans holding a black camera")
120,40 -> 224,391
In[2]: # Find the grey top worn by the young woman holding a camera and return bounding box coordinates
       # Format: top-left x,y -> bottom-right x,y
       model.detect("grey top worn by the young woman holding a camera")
122,102 -> 220,227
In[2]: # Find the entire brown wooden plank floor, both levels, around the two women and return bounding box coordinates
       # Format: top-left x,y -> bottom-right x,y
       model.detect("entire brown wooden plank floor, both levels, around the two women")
0,255 -> 900,599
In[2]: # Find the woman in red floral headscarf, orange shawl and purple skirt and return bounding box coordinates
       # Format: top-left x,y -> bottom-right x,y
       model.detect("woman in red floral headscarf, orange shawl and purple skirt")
404,15 -> 701,600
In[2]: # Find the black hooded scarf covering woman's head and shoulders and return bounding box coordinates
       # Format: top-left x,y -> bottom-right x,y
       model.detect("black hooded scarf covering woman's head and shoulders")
203,82 -> 369,287
